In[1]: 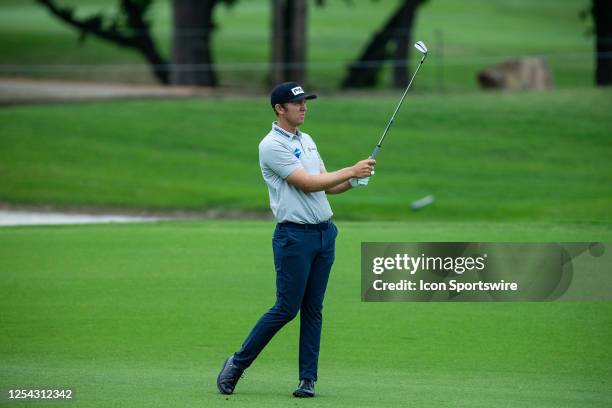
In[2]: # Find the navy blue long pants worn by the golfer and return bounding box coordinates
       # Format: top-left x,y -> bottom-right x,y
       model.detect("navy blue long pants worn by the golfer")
234,222 -> 338,381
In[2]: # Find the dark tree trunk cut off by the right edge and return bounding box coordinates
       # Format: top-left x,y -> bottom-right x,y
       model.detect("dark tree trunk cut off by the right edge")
591,0 -> 612,86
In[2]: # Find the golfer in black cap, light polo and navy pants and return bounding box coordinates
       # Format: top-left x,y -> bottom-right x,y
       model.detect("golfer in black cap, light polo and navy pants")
217,82 -> 375,397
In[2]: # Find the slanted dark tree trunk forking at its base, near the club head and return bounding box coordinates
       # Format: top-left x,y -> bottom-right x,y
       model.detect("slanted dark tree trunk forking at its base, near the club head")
342,0 -> 423,88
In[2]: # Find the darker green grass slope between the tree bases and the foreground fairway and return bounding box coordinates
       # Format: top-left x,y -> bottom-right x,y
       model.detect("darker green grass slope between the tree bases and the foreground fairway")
0,90 -> 612,223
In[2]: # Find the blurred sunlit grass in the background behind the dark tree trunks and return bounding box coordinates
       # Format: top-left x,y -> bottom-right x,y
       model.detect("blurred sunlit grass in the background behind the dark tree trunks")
0,0 -> 594,90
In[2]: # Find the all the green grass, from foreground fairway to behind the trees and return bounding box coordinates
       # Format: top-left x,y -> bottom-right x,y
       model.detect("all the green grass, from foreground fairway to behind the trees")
0,0 -> 612,408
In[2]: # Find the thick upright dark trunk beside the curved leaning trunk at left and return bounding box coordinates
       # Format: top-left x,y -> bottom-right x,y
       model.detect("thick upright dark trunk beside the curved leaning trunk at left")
170,0 -> 218,86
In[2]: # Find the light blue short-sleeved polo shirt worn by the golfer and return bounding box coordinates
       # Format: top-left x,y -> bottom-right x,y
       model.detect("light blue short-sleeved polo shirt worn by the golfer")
259,122 -> 333,224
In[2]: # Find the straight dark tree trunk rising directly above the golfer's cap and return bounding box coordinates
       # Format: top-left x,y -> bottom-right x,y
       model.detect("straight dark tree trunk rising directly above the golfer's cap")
271,0 -> 308,84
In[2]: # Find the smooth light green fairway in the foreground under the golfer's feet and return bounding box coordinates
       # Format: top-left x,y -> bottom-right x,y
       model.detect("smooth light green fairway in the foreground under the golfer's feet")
0,221 -> 612,408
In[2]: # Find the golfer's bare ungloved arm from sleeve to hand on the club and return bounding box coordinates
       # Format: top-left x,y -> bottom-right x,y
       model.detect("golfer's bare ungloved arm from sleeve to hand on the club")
287,159 -> 376,193
